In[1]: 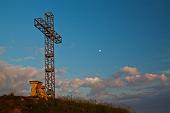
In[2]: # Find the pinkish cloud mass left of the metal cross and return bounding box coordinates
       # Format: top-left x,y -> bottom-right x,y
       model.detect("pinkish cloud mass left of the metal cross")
0,61 -> 43,94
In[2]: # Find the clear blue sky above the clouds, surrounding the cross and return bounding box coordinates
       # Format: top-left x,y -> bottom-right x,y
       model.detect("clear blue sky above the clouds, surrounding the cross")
0,0 -> 170,113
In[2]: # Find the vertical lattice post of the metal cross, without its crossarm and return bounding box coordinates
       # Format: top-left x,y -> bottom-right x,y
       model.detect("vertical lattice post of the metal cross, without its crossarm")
44,13 -> 55,97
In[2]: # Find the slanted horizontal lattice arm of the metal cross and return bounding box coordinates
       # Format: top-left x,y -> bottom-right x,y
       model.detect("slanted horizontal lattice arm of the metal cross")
34,18 -> 62,44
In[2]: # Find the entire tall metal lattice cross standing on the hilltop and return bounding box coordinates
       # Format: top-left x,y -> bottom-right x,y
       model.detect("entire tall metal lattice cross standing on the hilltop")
34,12 -> 62,98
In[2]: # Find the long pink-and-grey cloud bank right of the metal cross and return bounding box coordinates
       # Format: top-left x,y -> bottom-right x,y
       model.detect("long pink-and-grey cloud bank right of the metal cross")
56,66 -> 169,101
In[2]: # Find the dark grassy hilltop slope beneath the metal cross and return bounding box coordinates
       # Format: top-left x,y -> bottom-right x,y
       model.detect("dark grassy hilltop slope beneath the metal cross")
0,94 -> 132,113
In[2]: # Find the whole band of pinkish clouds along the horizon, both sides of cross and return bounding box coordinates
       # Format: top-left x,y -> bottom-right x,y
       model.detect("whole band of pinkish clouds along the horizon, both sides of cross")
0,61 -> 170,102
